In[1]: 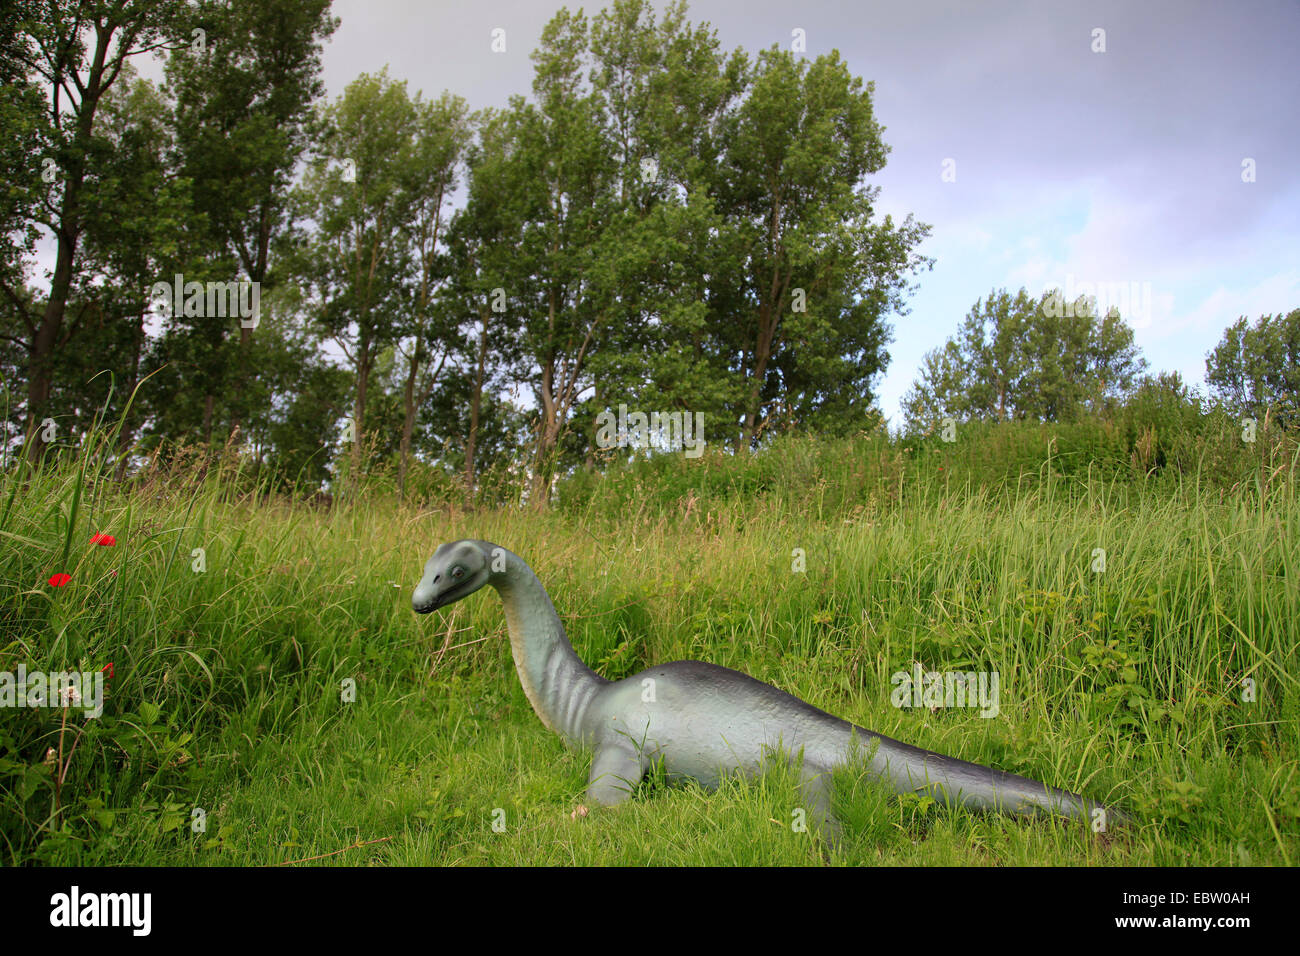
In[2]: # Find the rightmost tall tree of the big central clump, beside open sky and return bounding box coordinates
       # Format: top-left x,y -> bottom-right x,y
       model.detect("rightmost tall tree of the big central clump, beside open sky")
720,47 -> 928,444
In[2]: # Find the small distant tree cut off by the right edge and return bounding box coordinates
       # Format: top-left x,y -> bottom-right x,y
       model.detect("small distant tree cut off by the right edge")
1205,308 -> 1300,425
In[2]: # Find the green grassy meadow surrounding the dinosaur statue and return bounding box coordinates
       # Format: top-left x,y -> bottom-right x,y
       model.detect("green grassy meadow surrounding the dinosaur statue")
0,418 -> 1300,866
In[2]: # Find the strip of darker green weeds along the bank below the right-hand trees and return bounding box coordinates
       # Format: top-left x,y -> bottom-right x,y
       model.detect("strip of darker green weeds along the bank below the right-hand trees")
556,403 -> 1297,519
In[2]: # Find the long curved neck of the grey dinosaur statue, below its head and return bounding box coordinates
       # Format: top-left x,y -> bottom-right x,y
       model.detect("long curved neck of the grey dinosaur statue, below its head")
493,549 -> 610,743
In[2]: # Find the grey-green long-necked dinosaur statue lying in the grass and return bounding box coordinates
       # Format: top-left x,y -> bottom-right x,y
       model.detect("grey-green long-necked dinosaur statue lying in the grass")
411,540 -> 1127,836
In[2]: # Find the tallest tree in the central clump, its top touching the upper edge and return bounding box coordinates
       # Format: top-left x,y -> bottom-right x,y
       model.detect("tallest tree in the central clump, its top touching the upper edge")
582,0 -> 749,457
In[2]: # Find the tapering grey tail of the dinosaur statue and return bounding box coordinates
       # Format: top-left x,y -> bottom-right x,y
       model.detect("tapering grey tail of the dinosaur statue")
849,727 -> 1131,826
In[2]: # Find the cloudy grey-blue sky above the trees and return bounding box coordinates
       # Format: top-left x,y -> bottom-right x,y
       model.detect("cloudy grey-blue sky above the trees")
78,0 -> 1300,425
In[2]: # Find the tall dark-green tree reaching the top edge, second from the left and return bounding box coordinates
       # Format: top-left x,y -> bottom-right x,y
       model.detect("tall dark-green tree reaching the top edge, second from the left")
153,0 -> 338,447
